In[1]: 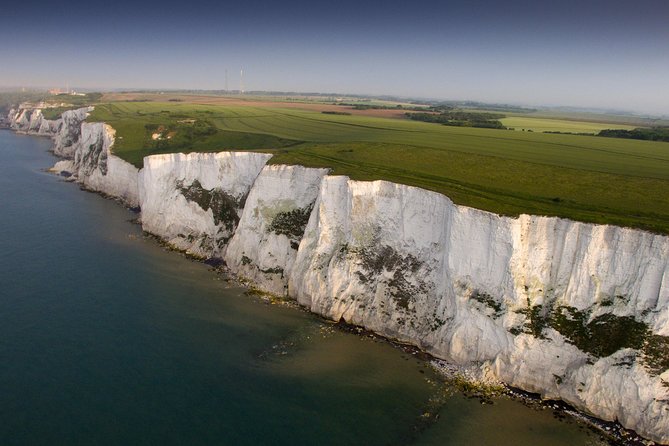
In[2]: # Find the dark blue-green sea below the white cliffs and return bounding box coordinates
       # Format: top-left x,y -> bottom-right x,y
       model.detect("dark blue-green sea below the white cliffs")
0,130 -> 598,446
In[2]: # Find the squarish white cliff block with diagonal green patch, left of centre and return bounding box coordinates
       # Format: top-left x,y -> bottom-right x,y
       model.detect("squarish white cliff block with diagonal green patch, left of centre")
139,152 -> 270,258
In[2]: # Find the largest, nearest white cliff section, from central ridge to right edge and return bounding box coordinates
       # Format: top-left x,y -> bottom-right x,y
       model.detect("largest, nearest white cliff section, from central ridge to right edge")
289,177 -> 669,442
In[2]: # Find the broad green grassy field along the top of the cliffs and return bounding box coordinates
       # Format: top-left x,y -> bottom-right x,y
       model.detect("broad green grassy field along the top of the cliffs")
89,102 -> 669,233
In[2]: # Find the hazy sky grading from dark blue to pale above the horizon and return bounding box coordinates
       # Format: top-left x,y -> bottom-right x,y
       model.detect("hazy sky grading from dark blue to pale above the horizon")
0,0 -> 669,115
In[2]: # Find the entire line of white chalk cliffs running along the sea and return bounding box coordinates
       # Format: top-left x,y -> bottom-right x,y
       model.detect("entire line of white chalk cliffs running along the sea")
8,105 -> 669,443
